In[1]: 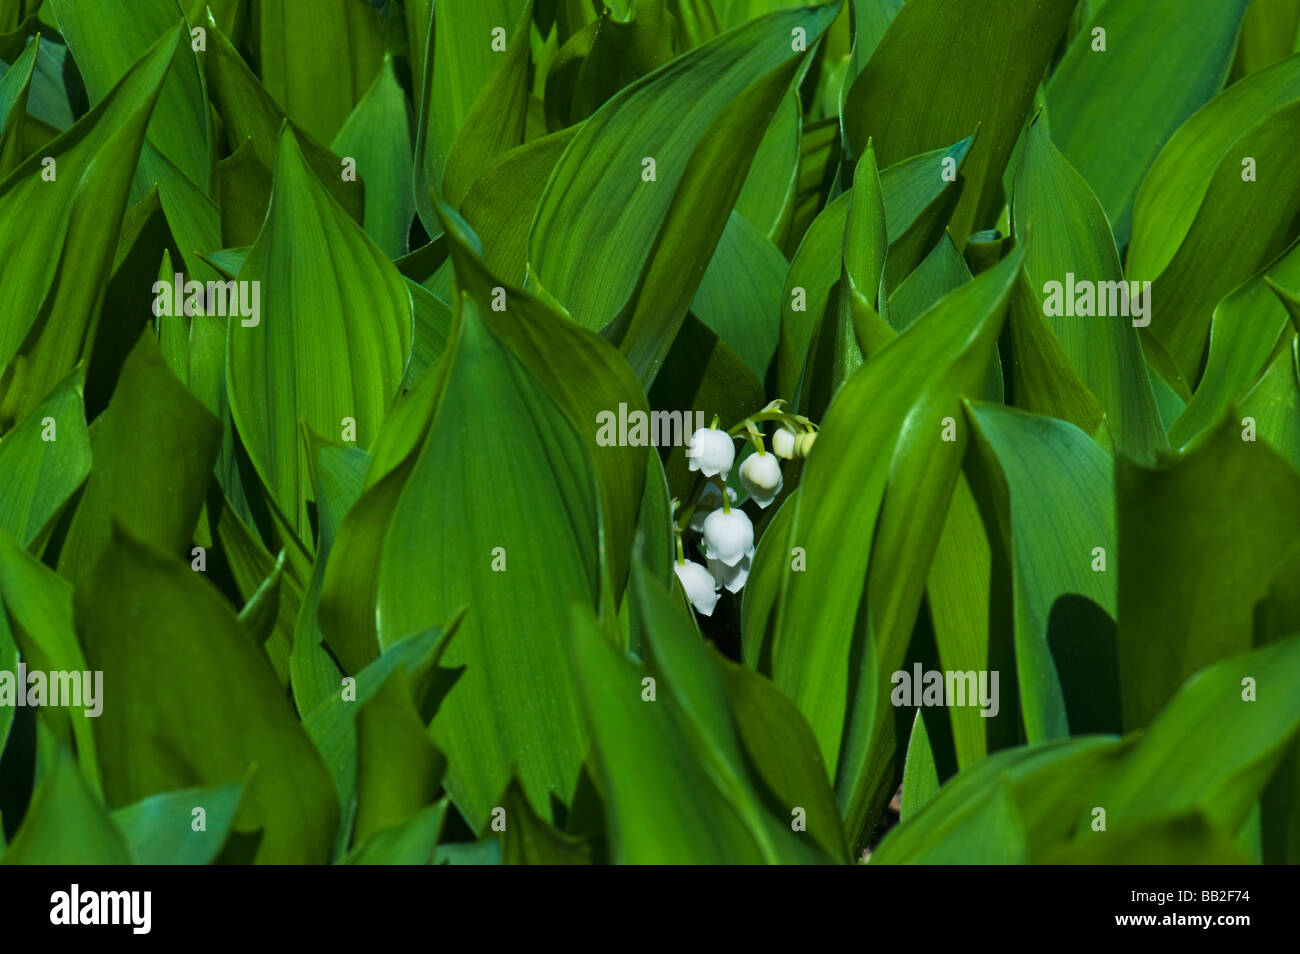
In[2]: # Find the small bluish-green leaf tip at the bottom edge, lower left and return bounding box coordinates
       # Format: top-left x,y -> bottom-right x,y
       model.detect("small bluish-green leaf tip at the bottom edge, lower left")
112,782 -> 244,864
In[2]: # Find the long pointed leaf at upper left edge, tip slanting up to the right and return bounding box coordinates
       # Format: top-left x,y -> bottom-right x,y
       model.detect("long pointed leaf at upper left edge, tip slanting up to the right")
0,27 -> 182,426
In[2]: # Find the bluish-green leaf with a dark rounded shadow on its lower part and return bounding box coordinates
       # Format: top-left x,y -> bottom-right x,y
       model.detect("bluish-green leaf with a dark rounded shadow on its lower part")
969,404 -> 1119,742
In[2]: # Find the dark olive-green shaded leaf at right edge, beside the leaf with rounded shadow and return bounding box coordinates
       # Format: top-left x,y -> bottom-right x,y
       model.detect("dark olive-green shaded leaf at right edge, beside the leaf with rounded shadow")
1115,419 -> 1300,729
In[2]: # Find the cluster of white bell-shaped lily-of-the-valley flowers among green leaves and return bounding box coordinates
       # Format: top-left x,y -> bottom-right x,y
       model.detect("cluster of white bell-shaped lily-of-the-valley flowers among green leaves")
673,400 -> 816,616
